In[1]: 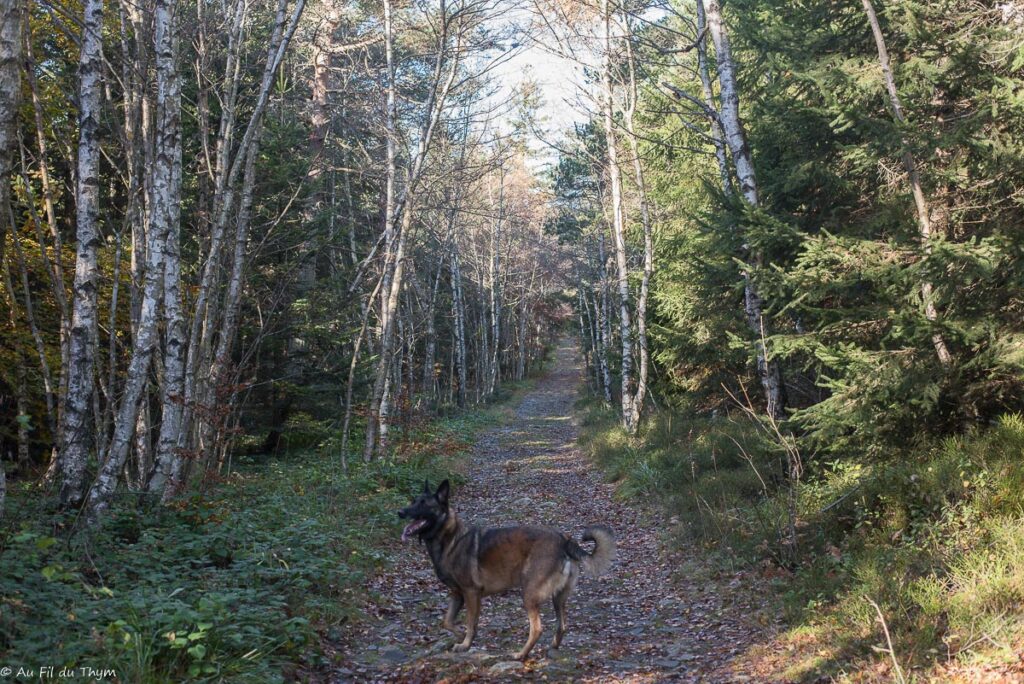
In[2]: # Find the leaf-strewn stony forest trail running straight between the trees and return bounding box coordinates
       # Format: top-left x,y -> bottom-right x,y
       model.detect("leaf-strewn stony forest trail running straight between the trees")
334,341 -> 765,683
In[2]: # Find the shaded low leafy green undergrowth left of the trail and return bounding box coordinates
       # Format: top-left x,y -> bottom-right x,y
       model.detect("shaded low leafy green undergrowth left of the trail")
0,408 -> 512,682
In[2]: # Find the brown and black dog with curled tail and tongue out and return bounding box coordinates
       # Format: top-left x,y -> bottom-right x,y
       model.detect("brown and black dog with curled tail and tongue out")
398,480 -> 615,660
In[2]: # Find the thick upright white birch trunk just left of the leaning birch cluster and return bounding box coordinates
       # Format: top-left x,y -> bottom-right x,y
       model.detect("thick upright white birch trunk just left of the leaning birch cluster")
60,0 -> 103,508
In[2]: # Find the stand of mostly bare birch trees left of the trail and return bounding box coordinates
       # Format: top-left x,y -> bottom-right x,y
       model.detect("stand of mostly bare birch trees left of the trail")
4,0 -> 560,520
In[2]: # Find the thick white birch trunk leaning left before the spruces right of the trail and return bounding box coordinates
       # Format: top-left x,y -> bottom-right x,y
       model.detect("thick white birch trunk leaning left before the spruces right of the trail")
707,0 -> 785,420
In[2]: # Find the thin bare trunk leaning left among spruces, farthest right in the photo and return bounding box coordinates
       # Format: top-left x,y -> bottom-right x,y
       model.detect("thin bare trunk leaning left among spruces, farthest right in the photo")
861,0 -> 952,366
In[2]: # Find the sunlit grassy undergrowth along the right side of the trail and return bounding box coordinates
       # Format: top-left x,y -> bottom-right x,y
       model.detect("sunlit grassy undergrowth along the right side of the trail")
581,398 -> 1024,681
